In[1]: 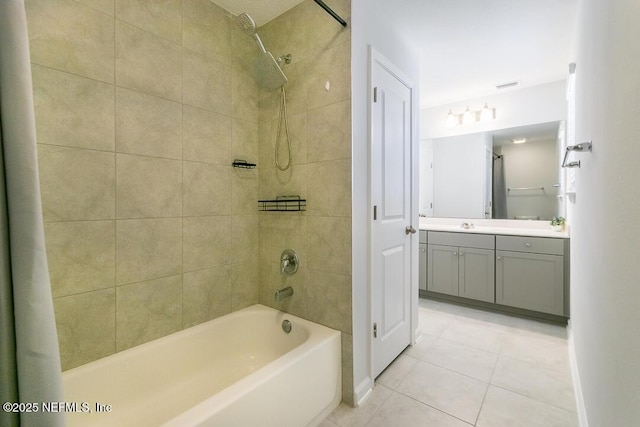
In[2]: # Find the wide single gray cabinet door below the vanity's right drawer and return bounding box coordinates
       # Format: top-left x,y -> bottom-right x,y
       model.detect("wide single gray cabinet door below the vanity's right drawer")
496,251 -> 564,316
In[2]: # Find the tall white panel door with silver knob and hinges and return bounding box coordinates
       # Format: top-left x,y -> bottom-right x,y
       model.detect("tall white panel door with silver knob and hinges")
371,49 -> 418,378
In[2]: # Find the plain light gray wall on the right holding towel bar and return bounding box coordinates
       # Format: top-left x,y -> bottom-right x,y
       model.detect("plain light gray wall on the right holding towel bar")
570,0 -> 640,427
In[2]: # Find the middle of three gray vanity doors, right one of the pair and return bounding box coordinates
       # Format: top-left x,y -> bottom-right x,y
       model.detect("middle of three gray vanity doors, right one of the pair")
458,248 -> 495,302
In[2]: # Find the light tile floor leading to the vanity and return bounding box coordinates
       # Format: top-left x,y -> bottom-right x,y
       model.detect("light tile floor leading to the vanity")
320,299 -> 578,427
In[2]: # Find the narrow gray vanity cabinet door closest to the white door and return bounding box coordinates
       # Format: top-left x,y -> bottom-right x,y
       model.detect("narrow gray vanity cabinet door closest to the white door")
427,245 -> 458,295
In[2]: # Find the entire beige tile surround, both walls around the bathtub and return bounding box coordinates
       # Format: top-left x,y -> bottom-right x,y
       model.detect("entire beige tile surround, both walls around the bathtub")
27,0 -> 353,402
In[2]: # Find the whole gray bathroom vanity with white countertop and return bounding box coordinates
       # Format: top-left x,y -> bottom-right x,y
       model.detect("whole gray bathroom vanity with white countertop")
419,219 -> 569,322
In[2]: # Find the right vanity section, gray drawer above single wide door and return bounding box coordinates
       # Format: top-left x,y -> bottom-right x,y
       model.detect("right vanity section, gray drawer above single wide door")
496,236 -> 565,316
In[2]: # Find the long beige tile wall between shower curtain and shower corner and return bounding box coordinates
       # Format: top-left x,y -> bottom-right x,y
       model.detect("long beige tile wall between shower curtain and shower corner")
26,0 -> 259,369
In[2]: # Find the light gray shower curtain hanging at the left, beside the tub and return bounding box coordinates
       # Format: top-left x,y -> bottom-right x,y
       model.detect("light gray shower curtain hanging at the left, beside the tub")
0,0 -> 65,427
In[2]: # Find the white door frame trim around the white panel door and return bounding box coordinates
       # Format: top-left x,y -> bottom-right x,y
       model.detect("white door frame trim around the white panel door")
367,45 -> 420,385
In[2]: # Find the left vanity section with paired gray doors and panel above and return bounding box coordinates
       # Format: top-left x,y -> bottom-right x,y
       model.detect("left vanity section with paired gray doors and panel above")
427,232 -> 495,303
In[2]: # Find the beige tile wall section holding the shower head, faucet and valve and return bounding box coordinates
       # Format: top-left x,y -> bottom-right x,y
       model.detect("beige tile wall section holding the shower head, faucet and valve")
259,0 -> 353,403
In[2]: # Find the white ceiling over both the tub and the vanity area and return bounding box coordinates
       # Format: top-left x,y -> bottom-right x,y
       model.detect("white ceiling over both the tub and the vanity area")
214,0 -> 577,108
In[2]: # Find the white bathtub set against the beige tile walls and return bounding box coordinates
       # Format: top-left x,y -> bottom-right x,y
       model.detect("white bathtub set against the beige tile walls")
63,305 -> 342,427
